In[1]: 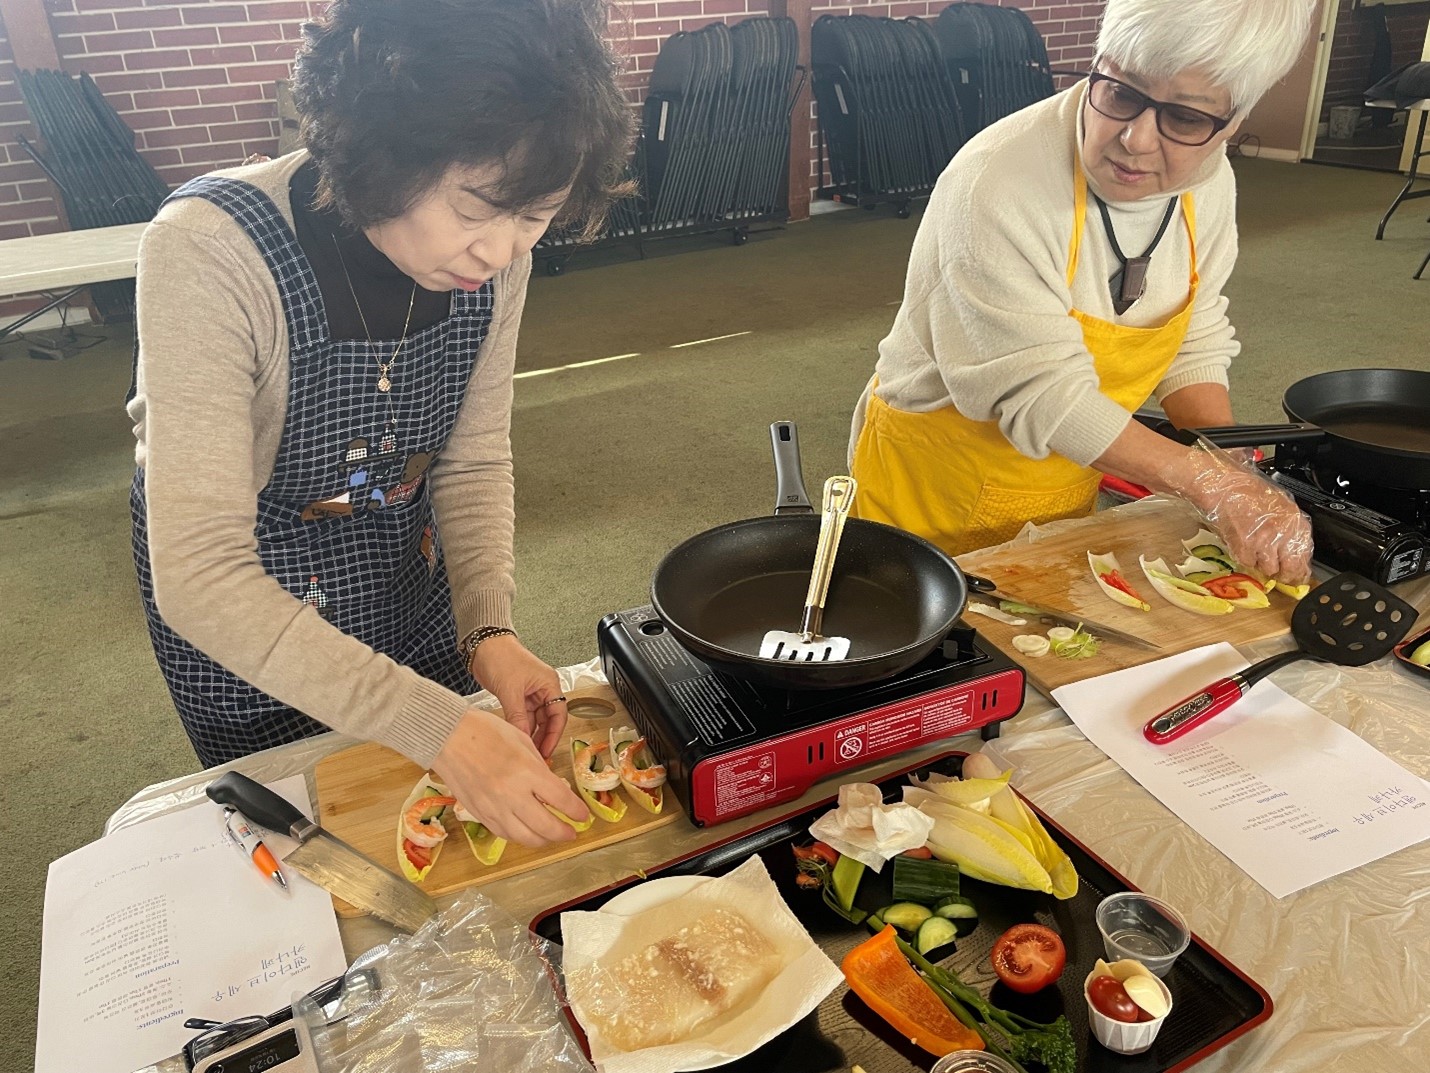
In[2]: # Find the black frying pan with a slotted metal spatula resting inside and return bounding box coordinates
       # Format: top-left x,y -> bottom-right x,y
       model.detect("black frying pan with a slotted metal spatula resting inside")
651,422 -> 968,690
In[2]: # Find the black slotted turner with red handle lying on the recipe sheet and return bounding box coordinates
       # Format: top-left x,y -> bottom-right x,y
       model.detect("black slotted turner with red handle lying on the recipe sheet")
1143,571 -> 1417,745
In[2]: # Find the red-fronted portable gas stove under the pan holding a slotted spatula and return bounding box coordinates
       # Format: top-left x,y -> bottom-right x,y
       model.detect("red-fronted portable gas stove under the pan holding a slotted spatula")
596,607 -> 1024,827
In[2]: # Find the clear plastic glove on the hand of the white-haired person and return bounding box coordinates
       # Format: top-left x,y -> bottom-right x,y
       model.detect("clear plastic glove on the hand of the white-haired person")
1163,441 -> 1311,585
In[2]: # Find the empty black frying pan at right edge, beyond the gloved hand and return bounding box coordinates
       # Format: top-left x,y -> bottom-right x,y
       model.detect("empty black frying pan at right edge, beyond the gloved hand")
1155,369 -> 1430,489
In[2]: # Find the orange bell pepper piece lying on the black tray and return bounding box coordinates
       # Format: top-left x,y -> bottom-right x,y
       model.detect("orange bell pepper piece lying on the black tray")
839,924 -> 984,1056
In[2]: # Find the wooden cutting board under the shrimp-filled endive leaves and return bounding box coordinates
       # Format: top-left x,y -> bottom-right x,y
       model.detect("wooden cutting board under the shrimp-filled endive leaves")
313,685 -> 684,917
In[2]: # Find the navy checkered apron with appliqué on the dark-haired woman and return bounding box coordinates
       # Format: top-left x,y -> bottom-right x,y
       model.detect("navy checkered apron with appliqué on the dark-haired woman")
130,177 -> 492,767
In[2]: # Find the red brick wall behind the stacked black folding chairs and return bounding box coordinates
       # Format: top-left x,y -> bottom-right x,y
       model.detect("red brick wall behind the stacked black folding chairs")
0,0 -> 1103,246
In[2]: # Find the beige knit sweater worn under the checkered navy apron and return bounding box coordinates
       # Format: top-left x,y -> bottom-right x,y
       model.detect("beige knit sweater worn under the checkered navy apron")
129,152 -> 531,767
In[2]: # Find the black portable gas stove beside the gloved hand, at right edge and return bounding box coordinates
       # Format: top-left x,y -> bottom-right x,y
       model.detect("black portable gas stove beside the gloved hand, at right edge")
1261,442 -> 1430,585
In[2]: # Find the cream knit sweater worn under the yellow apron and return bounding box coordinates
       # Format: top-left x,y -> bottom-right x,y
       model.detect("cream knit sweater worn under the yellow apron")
849,83 -> 1240,465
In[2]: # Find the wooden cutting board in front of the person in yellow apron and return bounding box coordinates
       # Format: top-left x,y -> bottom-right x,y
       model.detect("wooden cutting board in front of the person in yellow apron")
958,498 -> 1296,694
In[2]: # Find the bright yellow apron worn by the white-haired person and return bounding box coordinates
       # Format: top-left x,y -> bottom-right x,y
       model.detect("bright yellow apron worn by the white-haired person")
854,172 -> 1200,555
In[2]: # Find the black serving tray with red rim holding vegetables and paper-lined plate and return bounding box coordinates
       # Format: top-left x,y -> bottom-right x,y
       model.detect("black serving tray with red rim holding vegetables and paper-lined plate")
532,753 -> 1271,1073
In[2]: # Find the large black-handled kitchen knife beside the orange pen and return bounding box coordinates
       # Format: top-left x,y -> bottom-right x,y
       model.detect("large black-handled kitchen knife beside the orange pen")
204,771 -> 438,931
